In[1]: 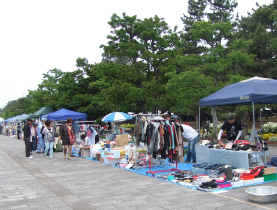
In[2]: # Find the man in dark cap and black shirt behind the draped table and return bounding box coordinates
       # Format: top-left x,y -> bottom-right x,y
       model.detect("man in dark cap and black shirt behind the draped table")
218,112 -> 242,144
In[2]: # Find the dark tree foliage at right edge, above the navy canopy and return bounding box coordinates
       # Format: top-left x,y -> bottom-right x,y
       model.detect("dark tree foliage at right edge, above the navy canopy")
236,1 -> 277,79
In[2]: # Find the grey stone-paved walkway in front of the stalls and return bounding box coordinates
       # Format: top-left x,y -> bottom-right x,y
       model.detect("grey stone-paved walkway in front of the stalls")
0,135 -> 277,210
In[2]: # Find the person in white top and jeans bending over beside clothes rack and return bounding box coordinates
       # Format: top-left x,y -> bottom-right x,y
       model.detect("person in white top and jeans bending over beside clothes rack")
182,124 -> 199,163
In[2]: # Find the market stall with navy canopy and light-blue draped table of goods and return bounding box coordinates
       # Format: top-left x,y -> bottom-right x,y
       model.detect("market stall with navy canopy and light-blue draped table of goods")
192,77 -> 277,190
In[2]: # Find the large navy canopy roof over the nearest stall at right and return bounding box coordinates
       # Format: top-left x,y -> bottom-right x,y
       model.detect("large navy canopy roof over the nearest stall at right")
199,77 -> 277,107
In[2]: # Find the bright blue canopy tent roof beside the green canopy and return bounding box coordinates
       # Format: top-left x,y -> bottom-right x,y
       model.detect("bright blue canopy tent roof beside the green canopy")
47,109 -> 87,121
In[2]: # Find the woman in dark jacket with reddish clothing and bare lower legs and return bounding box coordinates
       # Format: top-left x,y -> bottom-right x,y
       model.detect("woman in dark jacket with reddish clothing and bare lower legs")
59,118 -> 76,160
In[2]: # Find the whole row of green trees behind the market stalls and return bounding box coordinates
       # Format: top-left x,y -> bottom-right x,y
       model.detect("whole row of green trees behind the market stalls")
1,0 -> 277,123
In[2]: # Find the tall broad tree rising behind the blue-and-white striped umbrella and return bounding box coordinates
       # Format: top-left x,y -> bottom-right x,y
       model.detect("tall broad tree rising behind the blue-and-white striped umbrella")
101,13 -> 180,113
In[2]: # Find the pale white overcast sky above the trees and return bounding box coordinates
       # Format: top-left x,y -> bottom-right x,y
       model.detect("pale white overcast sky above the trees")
0,0 -> 273,108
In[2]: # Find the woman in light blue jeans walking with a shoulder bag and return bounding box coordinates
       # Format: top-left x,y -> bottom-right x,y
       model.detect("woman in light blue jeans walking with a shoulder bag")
41,120 -> 55,158
